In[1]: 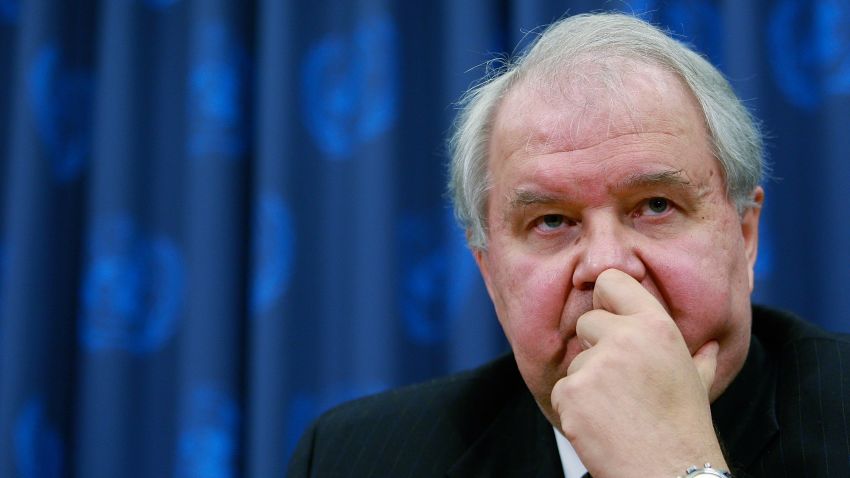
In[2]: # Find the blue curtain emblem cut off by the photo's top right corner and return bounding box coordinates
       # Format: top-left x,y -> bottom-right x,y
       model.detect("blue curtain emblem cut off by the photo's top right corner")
768,0 -> 850,108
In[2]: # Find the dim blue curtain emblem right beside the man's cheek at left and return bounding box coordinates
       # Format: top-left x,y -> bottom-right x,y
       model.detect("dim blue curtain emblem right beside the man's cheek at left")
399,209 -> 477,345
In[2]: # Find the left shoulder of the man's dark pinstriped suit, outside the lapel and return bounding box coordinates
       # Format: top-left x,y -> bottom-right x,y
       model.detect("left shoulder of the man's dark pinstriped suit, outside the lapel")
290,356 -> 529,477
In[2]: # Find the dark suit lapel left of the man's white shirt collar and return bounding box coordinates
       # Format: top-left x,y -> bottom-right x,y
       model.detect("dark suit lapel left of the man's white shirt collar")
448,384 -> 563,478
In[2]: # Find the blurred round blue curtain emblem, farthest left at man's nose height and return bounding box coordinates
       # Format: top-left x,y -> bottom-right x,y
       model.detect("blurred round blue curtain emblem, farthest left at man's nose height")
80,216 -> 185,353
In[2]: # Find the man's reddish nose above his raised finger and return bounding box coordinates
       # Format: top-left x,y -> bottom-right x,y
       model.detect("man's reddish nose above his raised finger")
573,217 -> 646,290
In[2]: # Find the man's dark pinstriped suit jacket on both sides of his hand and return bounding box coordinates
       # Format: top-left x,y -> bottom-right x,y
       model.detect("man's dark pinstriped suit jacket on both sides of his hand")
288,307 -> 850,478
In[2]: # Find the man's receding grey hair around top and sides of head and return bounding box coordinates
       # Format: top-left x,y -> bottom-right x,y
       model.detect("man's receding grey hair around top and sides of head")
449,13 -> 765,249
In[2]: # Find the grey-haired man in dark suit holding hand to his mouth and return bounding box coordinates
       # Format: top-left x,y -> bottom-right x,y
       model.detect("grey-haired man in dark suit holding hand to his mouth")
290,14 -> 850,478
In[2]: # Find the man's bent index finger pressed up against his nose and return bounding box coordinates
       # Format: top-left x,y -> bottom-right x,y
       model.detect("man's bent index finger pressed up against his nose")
593,269 -> 667,315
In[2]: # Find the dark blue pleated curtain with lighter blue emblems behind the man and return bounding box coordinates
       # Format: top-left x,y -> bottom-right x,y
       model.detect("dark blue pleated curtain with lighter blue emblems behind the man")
0,0 -> 850,478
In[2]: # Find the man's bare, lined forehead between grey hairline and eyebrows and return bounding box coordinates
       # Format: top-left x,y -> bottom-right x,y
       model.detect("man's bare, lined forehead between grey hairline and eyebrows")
486,57 -> 707,154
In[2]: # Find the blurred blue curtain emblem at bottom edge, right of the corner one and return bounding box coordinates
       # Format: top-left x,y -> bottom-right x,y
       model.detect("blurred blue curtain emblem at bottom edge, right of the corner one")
175,386 -> 239,478
